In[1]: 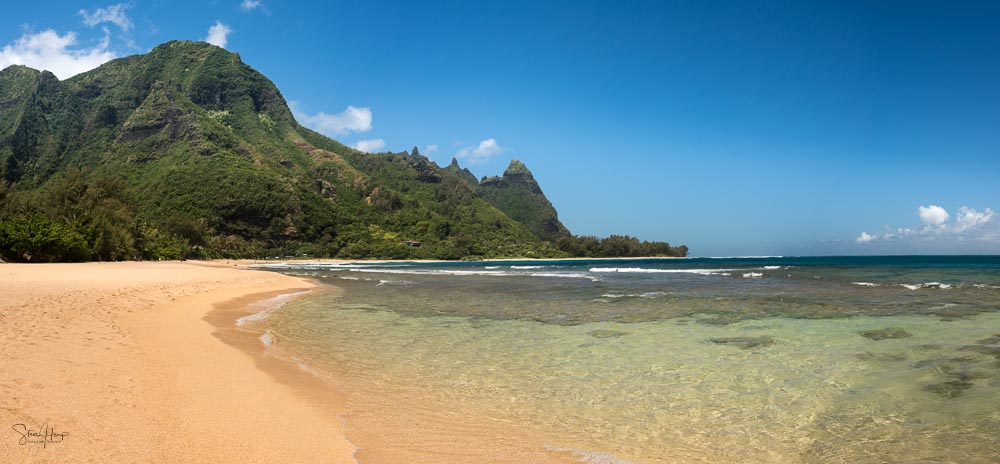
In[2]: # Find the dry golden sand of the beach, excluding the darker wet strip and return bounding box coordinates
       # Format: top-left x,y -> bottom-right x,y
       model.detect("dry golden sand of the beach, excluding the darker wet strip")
0,262 -> 354,463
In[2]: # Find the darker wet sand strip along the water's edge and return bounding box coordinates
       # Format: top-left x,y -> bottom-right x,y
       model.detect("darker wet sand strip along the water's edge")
206,264 -> 584,464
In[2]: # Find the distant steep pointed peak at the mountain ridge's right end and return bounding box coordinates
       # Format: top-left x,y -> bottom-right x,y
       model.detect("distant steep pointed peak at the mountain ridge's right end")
478,160 -> 570,241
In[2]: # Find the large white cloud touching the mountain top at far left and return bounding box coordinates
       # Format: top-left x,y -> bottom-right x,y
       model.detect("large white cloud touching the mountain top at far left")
0,29 -> 117,79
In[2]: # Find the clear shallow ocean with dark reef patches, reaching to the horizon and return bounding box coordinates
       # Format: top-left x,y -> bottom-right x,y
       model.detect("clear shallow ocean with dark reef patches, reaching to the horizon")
241,256 -> 1000,463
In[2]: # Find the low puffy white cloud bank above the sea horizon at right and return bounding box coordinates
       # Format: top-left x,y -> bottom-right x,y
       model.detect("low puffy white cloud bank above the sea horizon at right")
855,205 -> 1000,244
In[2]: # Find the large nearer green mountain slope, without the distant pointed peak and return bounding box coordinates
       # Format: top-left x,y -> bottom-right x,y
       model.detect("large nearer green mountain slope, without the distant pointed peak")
0,42 -> 556,258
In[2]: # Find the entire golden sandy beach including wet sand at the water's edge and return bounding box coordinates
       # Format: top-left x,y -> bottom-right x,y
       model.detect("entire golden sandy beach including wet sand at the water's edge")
0,261 -> 576,464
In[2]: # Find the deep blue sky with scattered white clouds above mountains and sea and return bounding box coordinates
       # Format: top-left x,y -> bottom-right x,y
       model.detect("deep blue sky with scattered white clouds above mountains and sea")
0,0 -> 1000,256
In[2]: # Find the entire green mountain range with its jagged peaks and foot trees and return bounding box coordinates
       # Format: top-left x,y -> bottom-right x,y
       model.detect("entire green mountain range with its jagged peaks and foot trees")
0,41 -> 688,261
